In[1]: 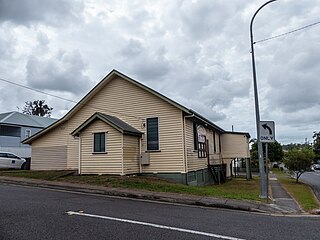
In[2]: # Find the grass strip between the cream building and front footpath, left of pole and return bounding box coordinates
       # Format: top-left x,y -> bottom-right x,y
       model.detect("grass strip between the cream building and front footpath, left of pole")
0,170 -> 262,201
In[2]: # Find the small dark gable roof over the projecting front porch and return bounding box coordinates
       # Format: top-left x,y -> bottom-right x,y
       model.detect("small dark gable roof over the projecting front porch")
71,112 -> 143,136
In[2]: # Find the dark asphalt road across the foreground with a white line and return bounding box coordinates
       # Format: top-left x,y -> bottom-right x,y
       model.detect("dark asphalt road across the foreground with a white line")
0,184 -> 320,240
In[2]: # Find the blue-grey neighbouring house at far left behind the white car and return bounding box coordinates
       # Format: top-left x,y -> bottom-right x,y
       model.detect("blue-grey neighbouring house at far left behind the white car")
0,112 -> 57,158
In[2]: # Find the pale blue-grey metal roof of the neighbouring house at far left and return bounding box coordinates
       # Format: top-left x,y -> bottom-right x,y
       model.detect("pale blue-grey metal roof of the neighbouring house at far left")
0,112 -> 57,128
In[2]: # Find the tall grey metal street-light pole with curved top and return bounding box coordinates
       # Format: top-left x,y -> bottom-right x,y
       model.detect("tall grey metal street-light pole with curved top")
250,0 -> 277,198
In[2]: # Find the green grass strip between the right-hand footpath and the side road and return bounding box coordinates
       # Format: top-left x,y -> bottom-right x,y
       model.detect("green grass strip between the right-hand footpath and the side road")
273,170 -> 320,211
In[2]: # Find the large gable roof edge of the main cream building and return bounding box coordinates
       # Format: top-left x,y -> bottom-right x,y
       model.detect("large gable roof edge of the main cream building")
22,69 -> 238,144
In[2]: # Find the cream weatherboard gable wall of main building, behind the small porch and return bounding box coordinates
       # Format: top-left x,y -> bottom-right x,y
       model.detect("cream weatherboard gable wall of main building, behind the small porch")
37,77 -> 184,173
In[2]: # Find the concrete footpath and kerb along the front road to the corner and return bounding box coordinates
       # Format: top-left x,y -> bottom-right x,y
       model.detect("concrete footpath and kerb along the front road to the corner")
0,175 -> 312,215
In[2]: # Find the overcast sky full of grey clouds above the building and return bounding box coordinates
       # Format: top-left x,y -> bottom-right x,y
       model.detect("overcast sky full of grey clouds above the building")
0,0 -> 320,144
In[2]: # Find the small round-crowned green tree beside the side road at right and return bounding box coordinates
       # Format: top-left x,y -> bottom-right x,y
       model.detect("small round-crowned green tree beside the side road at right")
284,147 -> 315,182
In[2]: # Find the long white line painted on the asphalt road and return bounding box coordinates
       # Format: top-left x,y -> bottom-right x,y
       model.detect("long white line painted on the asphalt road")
66,211 -> 245,240
